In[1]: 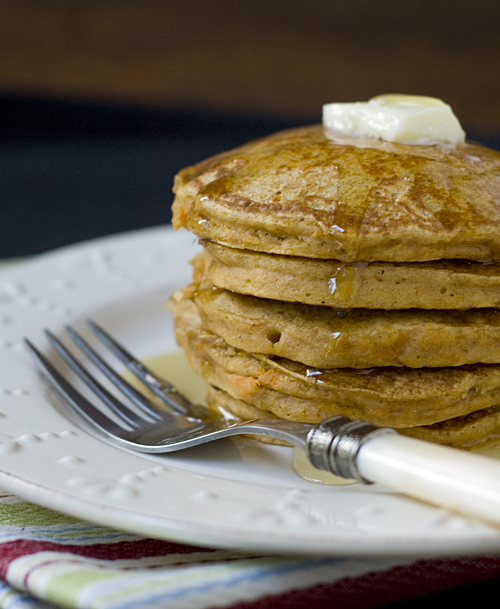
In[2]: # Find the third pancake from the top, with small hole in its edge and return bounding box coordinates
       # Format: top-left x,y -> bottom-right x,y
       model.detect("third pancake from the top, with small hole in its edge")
174,257 -> 500,368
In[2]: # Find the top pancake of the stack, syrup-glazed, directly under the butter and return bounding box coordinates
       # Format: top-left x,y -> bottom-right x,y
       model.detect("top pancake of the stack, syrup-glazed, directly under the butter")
173,125 -> 500,262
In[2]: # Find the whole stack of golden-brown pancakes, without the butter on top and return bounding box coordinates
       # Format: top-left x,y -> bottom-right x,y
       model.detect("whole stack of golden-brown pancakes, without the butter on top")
170,126 -> 500,447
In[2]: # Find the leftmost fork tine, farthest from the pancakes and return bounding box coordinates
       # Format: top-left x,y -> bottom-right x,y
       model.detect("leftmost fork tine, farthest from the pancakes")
24,338 -> 130,436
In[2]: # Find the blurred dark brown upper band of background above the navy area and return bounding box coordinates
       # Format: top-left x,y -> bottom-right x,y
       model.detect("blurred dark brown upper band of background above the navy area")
0,0 -> 500,133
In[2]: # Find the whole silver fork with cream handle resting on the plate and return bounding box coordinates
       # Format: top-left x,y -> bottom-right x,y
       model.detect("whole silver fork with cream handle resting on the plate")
25,320 -> 500,526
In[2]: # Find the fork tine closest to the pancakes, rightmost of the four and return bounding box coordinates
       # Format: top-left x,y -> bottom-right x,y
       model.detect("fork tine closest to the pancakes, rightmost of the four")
87,319 -> 193,414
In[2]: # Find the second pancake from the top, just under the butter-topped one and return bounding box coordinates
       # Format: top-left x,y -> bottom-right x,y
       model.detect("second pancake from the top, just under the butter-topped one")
202,241 -> 500,309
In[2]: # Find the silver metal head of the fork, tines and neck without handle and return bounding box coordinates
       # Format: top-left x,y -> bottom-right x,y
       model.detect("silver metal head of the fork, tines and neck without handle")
25,322 -> 311,453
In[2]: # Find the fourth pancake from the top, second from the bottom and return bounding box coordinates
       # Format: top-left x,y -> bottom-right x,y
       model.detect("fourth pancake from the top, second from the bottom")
170,300 -> 500,428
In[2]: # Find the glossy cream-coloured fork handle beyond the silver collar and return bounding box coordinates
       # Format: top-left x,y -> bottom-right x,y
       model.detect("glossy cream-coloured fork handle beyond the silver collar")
356,434 -> 500,526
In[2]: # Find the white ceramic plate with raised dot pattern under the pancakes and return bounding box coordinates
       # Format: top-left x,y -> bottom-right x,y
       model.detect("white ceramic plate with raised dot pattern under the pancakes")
0,228 -> 500,556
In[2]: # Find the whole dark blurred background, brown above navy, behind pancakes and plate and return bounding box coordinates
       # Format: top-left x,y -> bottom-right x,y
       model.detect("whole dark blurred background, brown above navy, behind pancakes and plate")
0,0 -> 500,258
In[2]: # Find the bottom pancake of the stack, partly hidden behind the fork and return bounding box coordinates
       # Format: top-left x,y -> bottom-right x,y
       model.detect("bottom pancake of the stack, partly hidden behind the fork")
206,387 -> 500,449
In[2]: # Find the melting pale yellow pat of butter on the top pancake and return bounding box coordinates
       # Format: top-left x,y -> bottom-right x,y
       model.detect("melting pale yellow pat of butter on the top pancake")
323,94 -> 465,145
